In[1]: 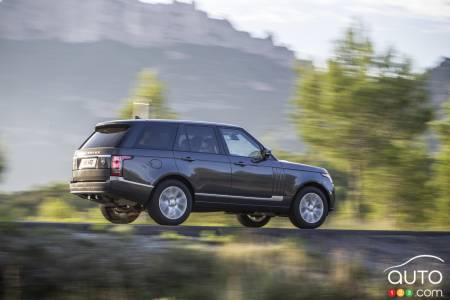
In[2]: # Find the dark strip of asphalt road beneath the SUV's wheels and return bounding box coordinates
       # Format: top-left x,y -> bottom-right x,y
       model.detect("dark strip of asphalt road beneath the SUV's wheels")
7,222 -> 450,270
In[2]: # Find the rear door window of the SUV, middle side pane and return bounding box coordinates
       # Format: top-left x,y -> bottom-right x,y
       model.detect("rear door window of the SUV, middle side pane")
186,125 -> 219,154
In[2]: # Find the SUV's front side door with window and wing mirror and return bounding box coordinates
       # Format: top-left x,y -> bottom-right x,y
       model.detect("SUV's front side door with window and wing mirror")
219,127 -> 278,200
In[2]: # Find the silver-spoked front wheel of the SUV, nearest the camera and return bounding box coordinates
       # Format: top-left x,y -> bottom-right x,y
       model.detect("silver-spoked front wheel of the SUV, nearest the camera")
289,186 -> 328,229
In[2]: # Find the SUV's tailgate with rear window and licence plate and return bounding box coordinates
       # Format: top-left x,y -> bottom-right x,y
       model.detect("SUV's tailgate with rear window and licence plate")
72,124 -> 130,182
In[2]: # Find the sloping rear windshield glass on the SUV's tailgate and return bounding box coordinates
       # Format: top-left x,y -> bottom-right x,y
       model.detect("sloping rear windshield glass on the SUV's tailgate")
81,126 -> 128,149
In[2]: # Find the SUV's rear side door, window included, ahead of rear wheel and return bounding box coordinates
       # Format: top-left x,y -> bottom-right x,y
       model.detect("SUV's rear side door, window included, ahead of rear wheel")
174,124 -> 231,198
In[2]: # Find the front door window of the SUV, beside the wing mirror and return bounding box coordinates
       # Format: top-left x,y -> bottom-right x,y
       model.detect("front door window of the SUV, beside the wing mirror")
220,128 -> 261,157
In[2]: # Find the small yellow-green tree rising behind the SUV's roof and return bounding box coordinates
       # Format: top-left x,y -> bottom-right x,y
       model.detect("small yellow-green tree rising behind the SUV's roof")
119,70 -> 176,119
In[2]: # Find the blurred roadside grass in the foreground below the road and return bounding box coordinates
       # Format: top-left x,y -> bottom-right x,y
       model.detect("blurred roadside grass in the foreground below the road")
0,229 -> 384,300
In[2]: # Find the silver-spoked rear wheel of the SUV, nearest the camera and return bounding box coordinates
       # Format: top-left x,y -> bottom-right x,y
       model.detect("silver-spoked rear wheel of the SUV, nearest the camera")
148,179 -> 192,225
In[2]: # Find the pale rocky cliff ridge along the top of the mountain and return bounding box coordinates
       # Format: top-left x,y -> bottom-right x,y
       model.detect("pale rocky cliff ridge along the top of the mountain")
0,0 -> 294,66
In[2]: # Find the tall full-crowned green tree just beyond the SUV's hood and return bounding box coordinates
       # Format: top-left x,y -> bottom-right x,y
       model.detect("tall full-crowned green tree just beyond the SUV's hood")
292,27 -> 432,216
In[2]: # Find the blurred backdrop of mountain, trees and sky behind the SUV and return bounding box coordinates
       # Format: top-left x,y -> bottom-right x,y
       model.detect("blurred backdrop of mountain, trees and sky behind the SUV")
0,0 -> 450,230
